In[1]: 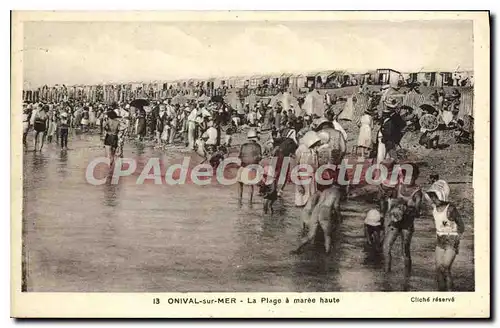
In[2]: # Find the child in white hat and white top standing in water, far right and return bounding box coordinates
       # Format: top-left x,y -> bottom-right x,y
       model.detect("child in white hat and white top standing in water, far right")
426,180 -> 465,291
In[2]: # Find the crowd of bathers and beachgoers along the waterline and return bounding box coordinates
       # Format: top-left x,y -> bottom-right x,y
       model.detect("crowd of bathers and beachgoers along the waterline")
23,81 -> 472,290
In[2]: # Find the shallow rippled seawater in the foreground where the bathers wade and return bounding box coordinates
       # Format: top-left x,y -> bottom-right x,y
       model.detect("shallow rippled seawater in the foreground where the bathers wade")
23,129 -> 474,292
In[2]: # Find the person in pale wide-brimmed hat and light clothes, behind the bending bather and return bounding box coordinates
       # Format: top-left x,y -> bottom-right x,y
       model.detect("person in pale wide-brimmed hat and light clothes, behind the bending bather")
295,131 -> 321,207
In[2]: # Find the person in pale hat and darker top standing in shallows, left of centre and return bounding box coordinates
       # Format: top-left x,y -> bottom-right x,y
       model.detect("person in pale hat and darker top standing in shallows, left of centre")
237,129 -> 262,204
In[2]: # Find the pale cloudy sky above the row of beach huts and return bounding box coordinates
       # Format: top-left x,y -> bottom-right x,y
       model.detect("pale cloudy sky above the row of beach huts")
23,21 -> 473,88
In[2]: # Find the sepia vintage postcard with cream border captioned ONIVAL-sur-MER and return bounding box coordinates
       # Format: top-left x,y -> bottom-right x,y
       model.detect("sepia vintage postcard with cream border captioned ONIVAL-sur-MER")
11,11 -> 490,318
